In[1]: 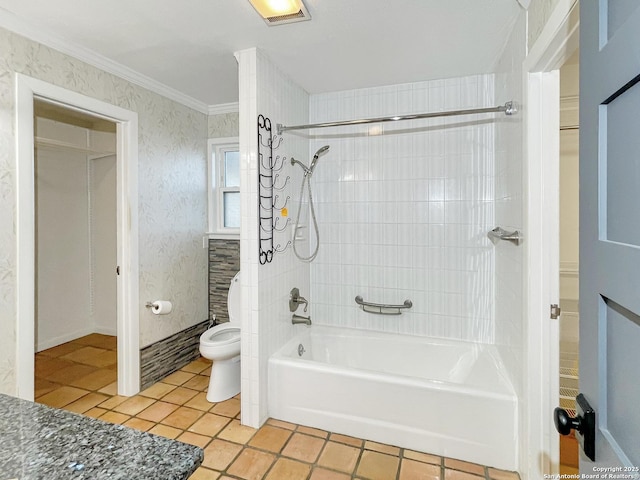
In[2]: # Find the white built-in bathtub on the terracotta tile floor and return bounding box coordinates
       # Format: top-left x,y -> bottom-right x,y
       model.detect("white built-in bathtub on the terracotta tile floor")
268,325 -> 518,470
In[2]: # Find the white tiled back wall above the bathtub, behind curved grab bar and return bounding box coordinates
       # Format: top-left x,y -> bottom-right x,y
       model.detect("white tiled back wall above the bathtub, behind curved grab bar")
309,74 -> 498,343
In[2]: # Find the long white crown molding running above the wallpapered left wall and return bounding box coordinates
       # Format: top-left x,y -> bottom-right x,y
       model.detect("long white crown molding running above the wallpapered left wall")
0,8 -> 210,114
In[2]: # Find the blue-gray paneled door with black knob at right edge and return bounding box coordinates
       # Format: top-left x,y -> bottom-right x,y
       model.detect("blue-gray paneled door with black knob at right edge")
580,0 -> 640,470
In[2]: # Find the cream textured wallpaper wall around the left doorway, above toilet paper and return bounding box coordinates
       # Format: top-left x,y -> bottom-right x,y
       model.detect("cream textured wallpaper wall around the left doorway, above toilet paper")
0,24 -> 208,394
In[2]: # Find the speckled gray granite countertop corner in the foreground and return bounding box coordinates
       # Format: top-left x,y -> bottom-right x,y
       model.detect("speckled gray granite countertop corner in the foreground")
0,394 -> 204,480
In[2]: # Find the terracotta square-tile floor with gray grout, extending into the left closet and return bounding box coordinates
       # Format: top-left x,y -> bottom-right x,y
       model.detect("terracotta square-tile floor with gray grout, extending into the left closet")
36,334 -> 518,480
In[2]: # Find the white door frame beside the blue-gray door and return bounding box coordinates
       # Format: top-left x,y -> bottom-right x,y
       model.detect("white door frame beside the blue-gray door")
521,0 -> 580,479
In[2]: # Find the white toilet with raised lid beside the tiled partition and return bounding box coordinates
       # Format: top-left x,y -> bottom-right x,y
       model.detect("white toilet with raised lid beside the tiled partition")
200,272 -> 241,402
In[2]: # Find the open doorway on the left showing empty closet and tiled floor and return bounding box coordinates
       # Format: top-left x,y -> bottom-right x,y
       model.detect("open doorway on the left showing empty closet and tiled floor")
34,103 -> 118,406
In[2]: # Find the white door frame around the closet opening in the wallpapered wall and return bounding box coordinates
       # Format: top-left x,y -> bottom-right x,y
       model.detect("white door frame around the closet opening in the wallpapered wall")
15,73 -> 140,400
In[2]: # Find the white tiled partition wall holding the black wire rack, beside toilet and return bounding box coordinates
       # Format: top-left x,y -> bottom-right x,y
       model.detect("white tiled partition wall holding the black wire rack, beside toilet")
238,49 -> 310,427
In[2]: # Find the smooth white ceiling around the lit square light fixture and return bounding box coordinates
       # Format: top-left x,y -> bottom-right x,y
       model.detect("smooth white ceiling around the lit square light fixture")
0,0 -> 520,105
